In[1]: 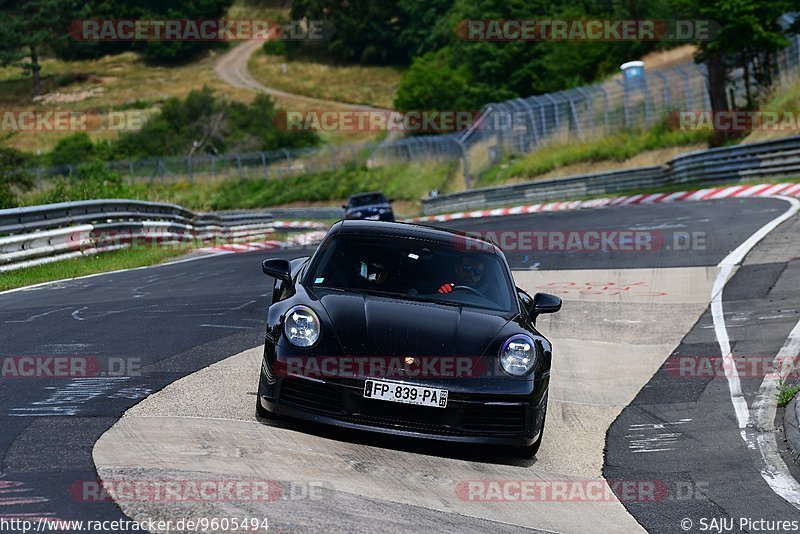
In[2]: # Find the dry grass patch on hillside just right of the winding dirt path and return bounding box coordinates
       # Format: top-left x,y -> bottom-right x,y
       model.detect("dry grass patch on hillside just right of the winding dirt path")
249,50 -> 403,108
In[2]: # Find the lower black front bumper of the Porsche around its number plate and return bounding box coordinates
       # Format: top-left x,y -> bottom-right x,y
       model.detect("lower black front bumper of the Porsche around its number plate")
258,362 -> 547,447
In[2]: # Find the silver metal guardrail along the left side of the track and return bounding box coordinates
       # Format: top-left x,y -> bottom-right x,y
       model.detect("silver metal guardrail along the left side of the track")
0,199 -> 343,272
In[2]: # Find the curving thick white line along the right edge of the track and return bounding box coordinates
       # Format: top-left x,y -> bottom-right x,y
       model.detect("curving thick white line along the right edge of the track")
711,197 -> 800,509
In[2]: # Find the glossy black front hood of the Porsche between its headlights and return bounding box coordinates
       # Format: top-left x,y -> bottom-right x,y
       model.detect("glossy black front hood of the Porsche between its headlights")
319,292 -> 509,357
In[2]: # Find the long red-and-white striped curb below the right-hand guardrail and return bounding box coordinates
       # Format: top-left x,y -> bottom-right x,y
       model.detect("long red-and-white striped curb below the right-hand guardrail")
405,183 -> 800,222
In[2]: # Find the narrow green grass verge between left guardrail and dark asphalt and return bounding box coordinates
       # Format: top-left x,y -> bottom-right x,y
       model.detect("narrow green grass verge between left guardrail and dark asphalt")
0,248 -> 187,291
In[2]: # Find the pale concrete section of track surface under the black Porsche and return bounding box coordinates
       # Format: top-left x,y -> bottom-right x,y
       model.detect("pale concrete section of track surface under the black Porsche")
93,267 -> 717,533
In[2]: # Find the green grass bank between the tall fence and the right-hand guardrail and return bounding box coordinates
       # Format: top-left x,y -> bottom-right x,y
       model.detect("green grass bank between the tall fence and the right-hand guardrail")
478,126 -> 710,186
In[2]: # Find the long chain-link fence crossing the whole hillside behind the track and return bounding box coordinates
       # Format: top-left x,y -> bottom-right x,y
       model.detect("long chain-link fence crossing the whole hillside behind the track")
6,35 -> 800,193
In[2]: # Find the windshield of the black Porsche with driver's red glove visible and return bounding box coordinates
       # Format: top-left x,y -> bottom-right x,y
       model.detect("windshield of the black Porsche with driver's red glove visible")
306,235 -> 515,311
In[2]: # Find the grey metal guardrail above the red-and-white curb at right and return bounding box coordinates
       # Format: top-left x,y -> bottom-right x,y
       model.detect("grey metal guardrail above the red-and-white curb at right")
422,136 -> 800,215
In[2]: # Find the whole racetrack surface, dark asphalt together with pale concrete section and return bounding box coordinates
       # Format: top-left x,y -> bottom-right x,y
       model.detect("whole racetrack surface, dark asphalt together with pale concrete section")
0,199 -> 798,532
